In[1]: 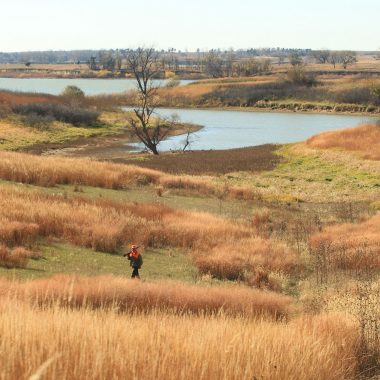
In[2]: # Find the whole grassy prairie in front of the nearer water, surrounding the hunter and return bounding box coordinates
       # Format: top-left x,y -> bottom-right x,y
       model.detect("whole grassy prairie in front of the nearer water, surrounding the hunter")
0,88 -> 380,380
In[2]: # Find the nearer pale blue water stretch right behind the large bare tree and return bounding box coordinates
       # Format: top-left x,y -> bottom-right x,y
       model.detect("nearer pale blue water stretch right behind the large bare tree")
126,109 -> 373,151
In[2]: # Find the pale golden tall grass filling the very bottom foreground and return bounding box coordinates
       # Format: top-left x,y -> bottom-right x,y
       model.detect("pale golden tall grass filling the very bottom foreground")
0,303 -> 358,380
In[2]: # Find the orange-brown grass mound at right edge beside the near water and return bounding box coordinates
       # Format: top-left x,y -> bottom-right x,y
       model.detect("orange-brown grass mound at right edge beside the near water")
306,124 -> 380,160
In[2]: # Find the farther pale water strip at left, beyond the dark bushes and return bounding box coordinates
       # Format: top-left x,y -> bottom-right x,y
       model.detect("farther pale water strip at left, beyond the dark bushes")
0,78 -> 193,95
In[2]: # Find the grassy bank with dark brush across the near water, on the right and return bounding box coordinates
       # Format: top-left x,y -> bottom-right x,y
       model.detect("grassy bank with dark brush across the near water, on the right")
151,74 -> 380,114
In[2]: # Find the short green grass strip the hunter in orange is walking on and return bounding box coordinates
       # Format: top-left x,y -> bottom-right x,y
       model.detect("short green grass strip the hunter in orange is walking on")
0,242 -> 197,281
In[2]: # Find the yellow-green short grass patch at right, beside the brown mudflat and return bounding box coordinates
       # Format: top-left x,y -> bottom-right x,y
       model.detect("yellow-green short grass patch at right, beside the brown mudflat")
218,145 -> 380,203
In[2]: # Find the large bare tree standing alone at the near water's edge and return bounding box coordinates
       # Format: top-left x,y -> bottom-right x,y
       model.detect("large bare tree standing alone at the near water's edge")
127,48 -> 174,154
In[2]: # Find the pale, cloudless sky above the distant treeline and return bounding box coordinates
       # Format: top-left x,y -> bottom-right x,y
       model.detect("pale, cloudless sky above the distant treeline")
0,0 -> 380,51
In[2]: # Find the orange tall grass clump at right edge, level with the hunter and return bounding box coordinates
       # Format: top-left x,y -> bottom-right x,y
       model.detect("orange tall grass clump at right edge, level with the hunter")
310,214 -> 380,269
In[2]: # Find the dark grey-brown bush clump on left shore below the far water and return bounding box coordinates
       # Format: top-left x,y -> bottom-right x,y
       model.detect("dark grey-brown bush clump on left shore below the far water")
12,103 -> 99,126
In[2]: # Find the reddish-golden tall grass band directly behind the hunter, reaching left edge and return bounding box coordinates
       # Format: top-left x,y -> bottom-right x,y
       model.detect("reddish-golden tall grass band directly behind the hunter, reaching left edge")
0,187 -> 301,280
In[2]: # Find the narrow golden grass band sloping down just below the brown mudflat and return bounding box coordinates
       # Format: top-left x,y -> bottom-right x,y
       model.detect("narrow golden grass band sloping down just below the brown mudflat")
0,152 -> 257,199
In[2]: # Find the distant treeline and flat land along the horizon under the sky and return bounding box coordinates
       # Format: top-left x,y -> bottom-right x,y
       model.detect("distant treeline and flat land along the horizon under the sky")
0,48 -> 380,82
